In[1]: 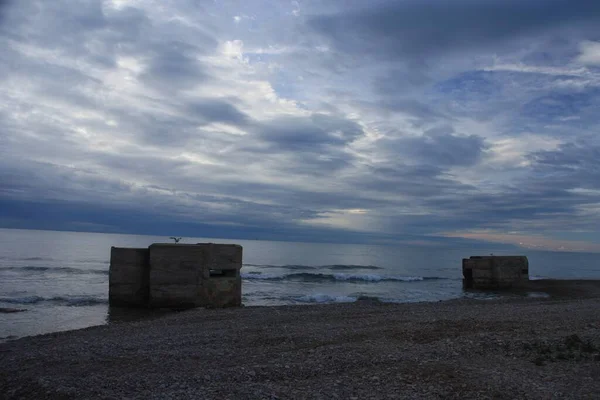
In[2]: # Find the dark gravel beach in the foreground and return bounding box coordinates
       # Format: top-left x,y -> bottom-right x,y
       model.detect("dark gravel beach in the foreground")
0,282 -> 600,399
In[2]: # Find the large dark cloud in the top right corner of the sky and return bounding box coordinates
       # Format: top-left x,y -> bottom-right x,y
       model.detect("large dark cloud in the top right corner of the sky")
310,0 -> 600,61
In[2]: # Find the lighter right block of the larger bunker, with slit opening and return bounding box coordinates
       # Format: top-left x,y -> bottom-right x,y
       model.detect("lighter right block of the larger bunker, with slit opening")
148,243 -> 242,308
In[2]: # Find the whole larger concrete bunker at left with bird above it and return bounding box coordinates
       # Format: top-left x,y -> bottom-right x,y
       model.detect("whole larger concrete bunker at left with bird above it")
109,243 -> 242,308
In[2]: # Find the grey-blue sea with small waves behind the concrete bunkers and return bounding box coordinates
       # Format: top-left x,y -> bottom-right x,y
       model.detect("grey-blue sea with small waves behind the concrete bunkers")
0,229 -> 600,341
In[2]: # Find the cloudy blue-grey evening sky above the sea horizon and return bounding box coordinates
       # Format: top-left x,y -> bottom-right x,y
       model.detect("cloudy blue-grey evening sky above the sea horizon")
0,0 -> 600,251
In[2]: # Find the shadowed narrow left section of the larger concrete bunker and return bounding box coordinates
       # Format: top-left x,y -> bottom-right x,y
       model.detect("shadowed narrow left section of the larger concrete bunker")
108,247 -> 149,307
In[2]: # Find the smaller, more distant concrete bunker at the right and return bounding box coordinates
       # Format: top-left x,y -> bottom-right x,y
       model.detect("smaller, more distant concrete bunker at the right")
463,256 -> 529,289
